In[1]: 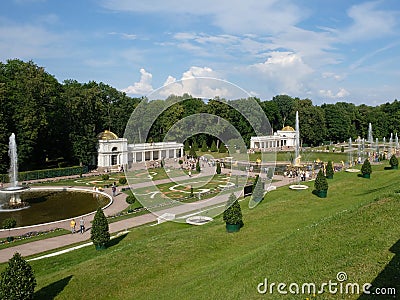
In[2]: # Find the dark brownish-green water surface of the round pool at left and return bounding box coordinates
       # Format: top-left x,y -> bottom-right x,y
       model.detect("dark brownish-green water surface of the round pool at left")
0,190 -> 110,227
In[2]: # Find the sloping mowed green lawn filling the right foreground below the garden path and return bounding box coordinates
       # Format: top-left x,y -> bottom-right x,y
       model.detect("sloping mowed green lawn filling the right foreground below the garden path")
2,166 -> 400,299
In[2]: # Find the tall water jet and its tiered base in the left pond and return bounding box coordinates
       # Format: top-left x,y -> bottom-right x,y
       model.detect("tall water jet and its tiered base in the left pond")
0,133 -> 29,208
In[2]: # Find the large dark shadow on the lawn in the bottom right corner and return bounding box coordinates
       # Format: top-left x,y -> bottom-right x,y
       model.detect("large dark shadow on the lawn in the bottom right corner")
358,240 -> 400,300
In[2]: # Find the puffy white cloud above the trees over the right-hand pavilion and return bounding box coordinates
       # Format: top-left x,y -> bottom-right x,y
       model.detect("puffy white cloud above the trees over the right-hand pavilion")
249,51 -> 313,95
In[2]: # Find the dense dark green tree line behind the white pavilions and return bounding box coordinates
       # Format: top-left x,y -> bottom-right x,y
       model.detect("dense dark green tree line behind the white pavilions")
0,59 -> 400,173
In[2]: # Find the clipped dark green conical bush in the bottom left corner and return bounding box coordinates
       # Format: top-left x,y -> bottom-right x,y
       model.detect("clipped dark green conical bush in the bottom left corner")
0,252 -> 36,299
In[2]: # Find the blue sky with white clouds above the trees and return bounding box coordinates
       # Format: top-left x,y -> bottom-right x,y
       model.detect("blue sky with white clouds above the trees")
0,0 -> 400,105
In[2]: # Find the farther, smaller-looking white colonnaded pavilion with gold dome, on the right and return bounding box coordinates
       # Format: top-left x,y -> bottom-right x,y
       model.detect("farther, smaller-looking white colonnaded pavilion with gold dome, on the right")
250,126 -> 296,152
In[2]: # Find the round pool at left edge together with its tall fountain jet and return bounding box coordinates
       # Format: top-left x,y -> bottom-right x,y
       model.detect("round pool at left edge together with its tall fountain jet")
0,133 -> 112,226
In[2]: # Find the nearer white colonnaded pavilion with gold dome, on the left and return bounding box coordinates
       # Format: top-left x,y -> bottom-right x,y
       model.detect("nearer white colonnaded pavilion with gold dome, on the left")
97,130 -> 184,169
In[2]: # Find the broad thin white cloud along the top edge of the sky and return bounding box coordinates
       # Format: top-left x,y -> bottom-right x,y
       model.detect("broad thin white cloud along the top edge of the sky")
102,0 -> 307,34
